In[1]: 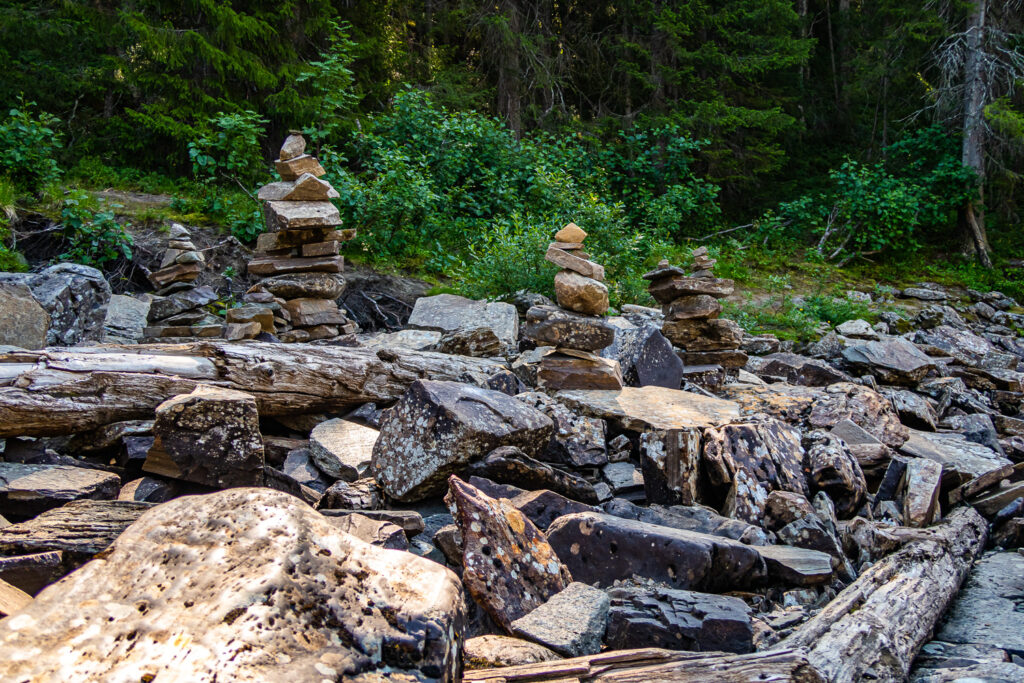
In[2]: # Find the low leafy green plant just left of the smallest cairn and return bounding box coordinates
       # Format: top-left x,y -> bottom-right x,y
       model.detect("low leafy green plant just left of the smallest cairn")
60,190 -> 132,268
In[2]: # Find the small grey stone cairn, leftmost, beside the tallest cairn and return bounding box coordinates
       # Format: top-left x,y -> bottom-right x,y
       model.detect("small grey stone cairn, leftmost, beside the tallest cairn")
143,223 -> 224,342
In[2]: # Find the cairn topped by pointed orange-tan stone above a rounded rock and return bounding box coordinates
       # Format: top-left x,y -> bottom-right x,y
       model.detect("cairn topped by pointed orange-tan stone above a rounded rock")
524,223 -> 623,390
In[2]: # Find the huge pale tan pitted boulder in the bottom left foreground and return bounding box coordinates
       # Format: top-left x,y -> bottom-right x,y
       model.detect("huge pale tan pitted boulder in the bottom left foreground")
0,488 -> 464,681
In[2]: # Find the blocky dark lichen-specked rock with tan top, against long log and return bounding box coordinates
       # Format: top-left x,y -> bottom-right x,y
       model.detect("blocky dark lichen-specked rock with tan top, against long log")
142,384 -> 264,488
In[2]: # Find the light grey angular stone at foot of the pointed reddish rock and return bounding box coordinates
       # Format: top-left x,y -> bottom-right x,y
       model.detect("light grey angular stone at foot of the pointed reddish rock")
512,583 -> 610,656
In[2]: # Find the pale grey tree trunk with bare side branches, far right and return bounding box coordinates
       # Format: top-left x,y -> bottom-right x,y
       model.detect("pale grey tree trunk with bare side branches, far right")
961,0 -> 992,268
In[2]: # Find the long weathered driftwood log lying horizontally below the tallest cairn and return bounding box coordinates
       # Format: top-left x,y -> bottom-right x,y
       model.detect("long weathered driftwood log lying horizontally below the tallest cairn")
0,342 -> 504,437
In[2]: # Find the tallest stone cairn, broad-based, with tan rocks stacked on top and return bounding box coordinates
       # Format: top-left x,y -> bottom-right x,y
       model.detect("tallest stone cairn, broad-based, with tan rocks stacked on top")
245,133 -> 357,342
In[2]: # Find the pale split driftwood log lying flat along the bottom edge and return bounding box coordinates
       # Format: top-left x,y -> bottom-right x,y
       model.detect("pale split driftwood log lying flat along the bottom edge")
463,648 -> 826,683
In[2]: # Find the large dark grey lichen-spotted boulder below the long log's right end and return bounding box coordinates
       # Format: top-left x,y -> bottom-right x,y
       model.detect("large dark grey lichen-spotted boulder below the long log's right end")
372,380 -> 554,502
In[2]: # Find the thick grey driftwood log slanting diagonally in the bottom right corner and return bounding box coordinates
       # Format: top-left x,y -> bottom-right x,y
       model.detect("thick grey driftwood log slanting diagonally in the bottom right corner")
778,508 -> 986,683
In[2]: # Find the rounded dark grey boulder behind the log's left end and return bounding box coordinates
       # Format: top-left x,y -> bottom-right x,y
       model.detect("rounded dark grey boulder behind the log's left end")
0,263 -> 111,346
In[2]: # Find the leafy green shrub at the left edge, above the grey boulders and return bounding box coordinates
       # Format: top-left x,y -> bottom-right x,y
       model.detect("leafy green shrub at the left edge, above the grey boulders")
0,98 -> 60,193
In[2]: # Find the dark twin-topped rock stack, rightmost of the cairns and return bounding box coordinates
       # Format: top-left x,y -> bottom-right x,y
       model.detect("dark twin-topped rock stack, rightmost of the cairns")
644,247 -> 746,378
